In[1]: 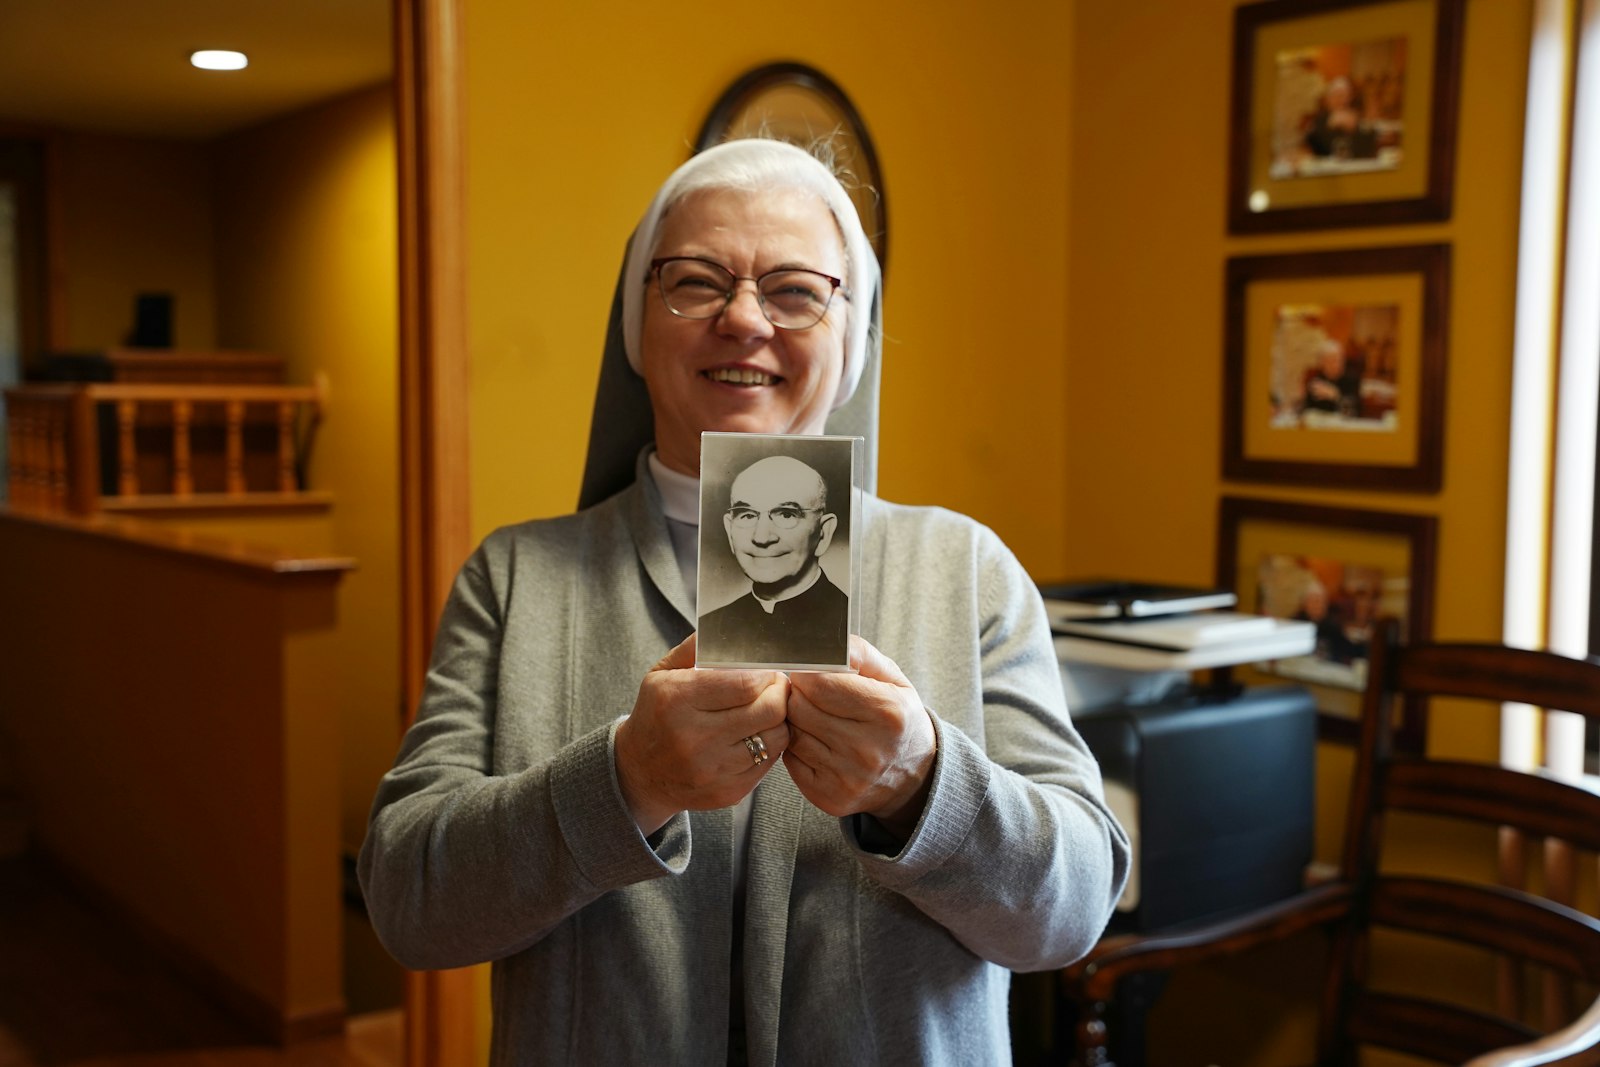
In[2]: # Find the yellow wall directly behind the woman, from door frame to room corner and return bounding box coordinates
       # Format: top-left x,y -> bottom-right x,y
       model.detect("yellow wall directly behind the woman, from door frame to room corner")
464,0 -> 1072,573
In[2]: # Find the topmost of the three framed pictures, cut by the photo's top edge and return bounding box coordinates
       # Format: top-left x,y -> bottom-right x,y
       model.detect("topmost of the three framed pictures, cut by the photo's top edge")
1227,0 -> 1464,234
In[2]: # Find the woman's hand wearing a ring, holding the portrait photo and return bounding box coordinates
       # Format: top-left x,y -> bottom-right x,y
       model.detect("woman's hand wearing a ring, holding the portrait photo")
616,633 -> 789,835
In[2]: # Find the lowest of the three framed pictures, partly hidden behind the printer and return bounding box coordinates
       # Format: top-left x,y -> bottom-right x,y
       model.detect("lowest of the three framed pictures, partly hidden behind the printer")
1216,496 -> 1438,744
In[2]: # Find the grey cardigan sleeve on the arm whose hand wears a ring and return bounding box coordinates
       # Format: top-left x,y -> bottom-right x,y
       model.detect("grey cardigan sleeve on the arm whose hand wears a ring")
358,547 -> 690,969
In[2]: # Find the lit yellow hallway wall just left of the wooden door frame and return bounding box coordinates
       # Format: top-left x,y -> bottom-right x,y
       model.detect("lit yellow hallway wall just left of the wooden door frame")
214,86 -> 400,853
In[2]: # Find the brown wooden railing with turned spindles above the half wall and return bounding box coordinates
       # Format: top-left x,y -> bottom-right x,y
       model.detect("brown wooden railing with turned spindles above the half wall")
5,382 -> 326,515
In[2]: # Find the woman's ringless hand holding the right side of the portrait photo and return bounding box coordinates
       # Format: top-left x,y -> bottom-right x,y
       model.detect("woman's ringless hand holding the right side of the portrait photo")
784,635 -> 936,841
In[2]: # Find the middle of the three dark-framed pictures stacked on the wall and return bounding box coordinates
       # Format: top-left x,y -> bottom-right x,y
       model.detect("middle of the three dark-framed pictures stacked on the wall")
1222,245 -> 1450,493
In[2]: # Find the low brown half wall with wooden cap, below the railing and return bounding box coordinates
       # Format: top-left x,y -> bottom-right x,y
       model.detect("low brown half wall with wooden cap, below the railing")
0,515 -> 344,1035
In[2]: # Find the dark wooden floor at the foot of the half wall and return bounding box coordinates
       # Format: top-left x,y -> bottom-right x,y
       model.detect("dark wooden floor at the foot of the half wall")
0,856 -> 402,1067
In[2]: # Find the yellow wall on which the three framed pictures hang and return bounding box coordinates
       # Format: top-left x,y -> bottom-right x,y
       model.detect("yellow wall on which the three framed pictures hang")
1059,0 -> 1531,1064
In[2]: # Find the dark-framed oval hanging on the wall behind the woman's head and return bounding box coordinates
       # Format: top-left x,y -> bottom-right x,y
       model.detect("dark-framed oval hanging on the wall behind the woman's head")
694,62 -> 890,277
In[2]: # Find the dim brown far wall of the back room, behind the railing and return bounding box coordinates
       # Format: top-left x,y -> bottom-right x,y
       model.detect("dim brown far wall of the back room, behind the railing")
51,133 -> 216,352
